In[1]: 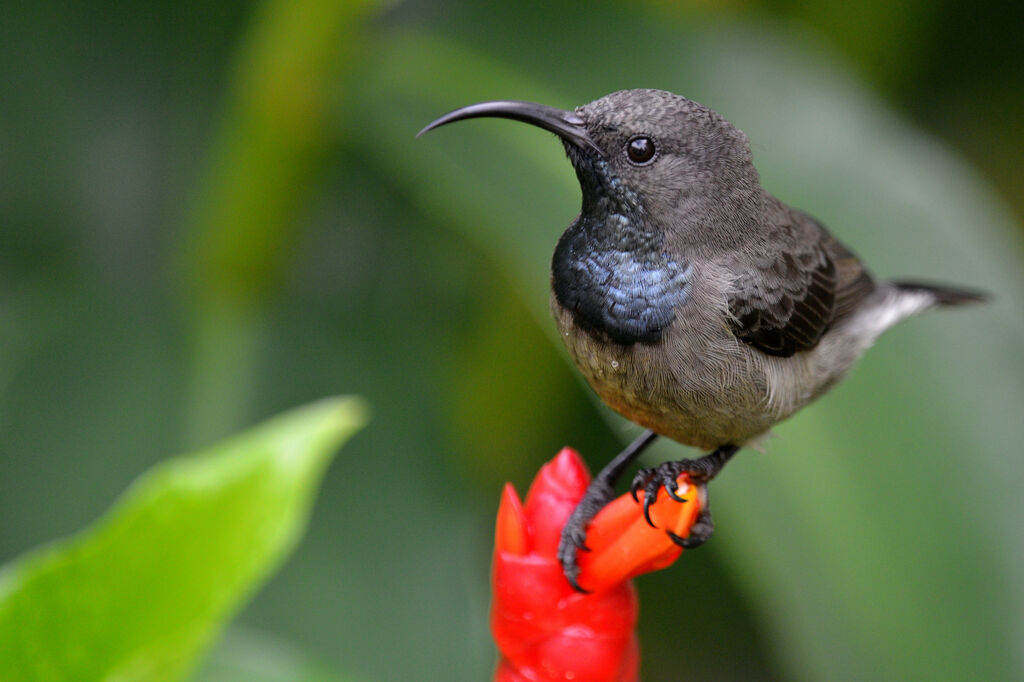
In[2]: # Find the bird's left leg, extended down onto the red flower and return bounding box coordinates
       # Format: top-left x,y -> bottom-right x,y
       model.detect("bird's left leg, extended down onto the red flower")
558,430 -> 657,592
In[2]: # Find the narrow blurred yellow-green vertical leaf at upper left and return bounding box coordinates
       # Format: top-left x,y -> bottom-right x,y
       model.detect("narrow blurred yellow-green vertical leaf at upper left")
180,0 -> 381,440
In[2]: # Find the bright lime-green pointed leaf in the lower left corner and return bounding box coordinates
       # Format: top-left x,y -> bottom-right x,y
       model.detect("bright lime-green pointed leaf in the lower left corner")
0,398 -> 366,682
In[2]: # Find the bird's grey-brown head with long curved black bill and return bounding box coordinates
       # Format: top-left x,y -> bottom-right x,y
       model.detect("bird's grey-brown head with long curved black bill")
420,90 -> 760,241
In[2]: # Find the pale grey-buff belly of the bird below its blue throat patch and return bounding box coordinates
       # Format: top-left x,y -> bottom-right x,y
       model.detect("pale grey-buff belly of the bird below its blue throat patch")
552,300 -> 792,450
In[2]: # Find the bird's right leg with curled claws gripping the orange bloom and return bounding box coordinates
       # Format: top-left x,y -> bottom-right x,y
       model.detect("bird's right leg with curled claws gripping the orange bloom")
626,445 -> 739,549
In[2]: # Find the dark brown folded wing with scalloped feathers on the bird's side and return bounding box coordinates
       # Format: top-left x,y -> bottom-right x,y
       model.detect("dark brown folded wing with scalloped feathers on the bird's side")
729,214 -> 873,357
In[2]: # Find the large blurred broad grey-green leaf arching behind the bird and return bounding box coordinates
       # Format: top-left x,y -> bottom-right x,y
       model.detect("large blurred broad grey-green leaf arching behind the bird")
349,13 -> 1024,680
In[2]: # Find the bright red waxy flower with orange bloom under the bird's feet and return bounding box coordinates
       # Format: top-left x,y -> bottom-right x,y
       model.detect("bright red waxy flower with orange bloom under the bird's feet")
490,447 -> 700,682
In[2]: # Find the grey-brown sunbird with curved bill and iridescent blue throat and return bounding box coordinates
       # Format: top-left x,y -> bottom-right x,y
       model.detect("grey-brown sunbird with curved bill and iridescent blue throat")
421,90 -> 984,589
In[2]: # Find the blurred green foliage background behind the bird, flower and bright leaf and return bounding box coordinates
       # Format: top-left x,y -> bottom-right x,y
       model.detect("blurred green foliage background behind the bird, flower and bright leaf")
0,0 -> 1024,682
